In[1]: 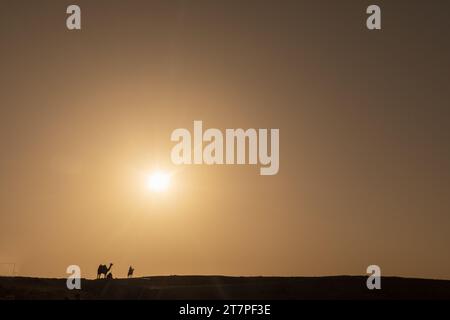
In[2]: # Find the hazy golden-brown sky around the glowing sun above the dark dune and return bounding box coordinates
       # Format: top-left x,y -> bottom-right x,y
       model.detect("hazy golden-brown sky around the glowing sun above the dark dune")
0,0 -> 450,279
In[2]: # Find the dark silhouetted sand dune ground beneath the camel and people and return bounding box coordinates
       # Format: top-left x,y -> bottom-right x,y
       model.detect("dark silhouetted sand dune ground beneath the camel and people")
0,276 -> 450,300
